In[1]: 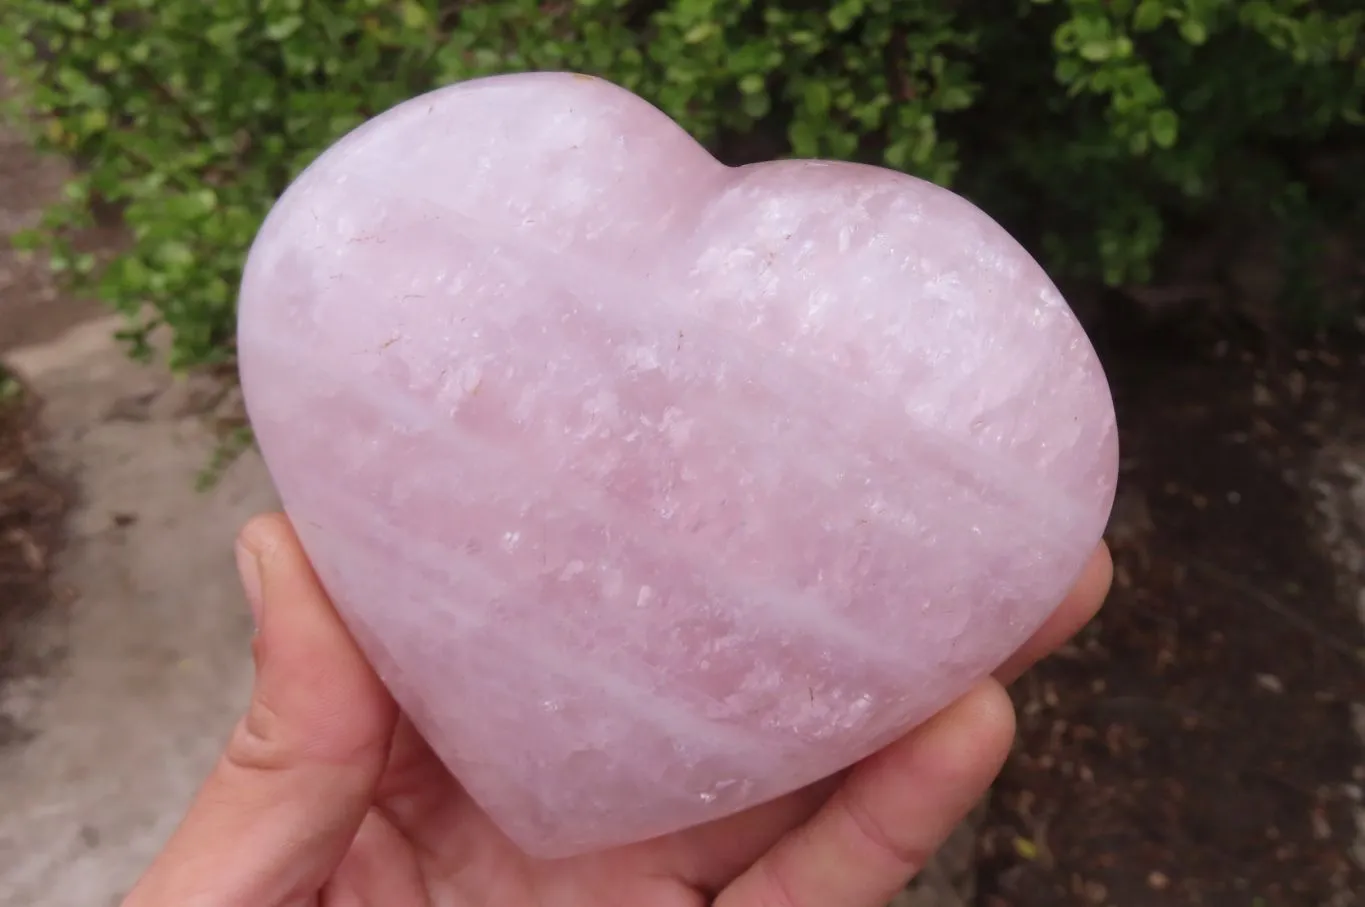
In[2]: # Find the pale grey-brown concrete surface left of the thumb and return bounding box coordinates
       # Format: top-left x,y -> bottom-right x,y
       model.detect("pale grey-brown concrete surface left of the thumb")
0,320 -> 274,907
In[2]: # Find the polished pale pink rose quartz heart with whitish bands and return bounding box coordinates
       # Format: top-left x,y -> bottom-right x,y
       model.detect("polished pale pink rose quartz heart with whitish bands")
239,74 -> 1117,856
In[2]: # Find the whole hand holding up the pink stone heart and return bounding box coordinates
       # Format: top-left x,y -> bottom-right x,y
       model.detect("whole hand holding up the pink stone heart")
123,515 -> 1111,907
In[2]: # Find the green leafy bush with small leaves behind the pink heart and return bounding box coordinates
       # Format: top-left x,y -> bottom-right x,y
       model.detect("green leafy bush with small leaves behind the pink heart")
0,0 -> 1365,365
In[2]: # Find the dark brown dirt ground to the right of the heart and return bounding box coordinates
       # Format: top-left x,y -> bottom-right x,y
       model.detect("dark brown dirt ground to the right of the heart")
980,318 -> 1365,907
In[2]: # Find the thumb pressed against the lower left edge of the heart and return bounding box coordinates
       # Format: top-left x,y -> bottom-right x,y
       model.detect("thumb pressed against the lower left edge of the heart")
124,515 -> 397,907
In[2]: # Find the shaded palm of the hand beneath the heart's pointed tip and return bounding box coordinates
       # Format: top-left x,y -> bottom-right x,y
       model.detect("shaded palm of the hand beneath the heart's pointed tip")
333,718 -> 835,907
